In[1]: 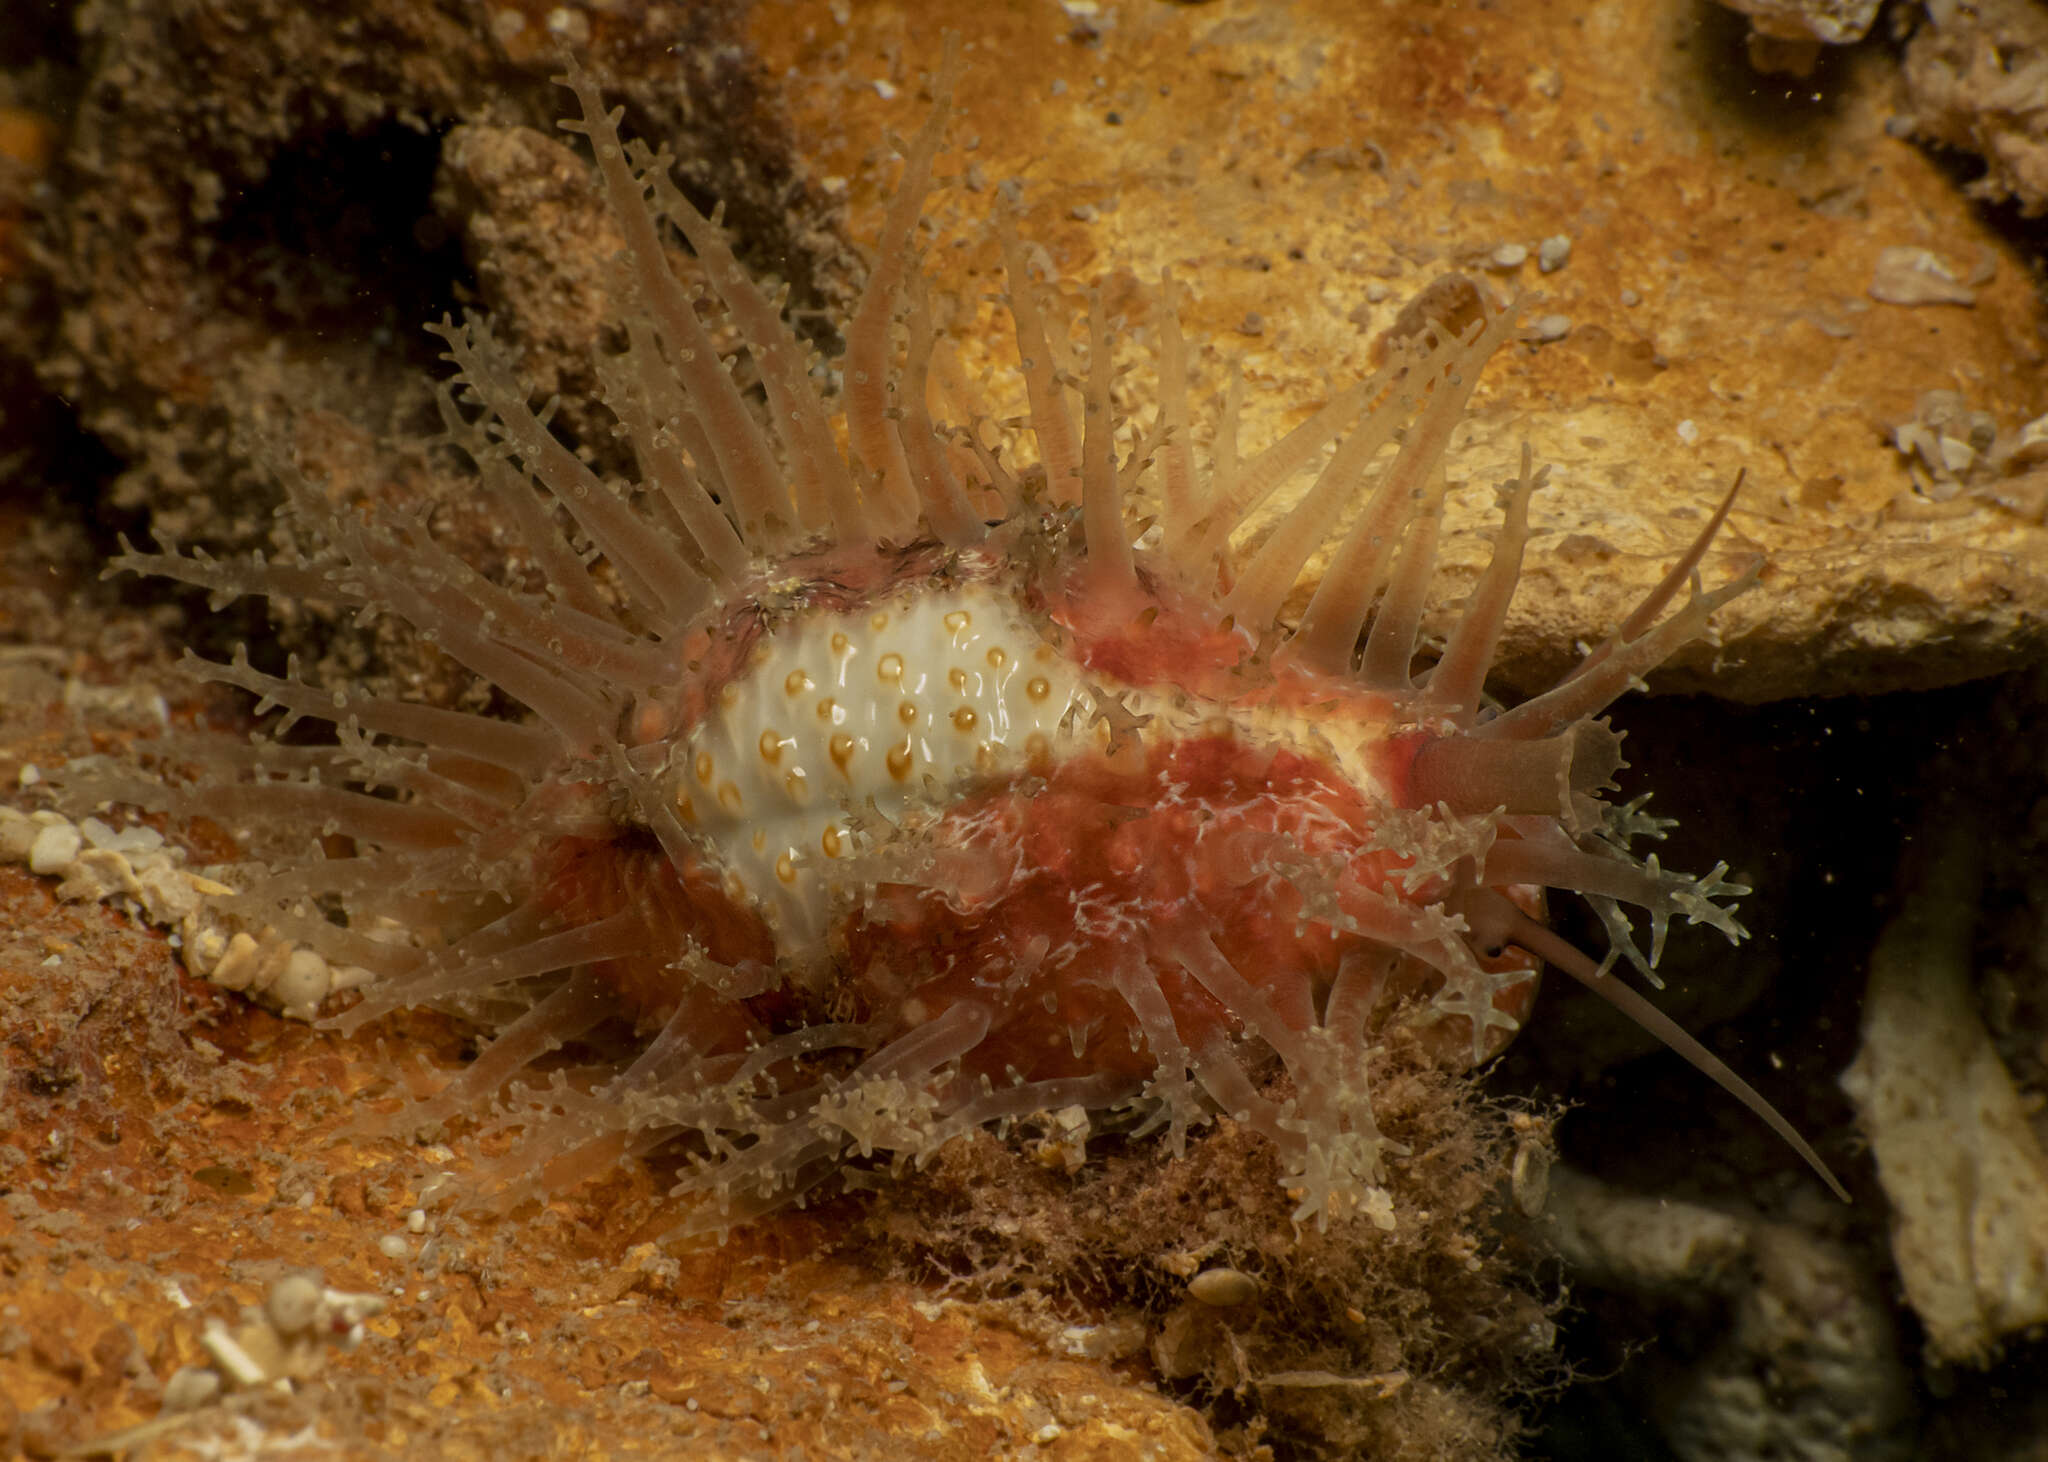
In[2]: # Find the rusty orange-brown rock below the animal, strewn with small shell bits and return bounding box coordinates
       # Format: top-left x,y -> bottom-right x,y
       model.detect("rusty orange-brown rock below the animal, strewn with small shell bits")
0,868 -> 1212,1460
